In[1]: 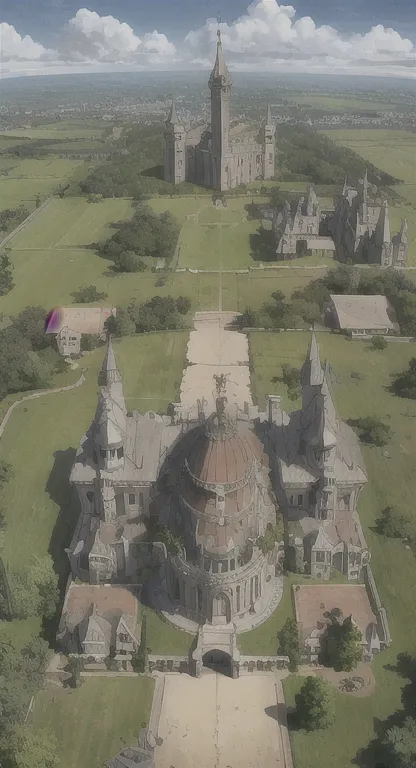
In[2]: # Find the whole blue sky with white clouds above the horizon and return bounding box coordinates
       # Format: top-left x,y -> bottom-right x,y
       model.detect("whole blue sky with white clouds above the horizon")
0,0 -> 416,79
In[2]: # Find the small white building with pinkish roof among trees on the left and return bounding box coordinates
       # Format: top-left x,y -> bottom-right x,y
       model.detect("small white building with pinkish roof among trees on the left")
46,307 -> 117,357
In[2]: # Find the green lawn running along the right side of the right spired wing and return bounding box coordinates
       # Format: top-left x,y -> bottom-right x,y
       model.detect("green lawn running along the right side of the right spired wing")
250,333 -> 416,768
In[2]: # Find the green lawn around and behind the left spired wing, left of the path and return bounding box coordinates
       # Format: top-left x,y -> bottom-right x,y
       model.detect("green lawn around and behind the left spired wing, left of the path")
0,331 -> 188,570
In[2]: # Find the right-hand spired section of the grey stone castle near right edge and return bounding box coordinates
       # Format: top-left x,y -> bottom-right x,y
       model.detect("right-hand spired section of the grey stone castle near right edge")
329,171 -> 409,267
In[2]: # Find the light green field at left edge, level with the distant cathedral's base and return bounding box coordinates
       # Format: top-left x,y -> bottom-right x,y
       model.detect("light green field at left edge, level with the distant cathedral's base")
0,156 -> 84,207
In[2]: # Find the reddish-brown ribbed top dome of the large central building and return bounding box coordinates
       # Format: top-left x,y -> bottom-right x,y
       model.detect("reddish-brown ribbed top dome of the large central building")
187,416 -> 267,485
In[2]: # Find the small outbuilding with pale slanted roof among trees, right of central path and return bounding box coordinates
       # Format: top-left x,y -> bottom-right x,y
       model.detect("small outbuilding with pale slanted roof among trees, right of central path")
325,294 -> 399,336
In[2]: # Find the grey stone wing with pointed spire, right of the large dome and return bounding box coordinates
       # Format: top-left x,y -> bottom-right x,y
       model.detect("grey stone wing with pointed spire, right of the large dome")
266,334 -> 370,579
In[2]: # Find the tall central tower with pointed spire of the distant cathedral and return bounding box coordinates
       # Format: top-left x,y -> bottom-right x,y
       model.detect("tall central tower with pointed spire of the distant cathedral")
208,30 -> 232,190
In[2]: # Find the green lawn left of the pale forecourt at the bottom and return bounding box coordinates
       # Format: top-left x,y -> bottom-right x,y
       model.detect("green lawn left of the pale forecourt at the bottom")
32,677 -> 154,768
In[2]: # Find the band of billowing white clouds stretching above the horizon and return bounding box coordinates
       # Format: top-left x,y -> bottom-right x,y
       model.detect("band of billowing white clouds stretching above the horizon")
1,0 -> 415,77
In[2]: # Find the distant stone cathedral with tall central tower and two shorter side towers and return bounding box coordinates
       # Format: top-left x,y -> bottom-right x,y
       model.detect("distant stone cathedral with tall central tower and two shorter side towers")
164,31 -> 276,191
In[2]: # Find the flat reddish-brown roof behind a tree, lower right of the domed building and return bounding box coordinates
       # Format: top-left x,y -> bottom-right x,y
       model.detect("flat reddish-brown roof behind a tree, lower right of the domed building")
293,584 -> 377,637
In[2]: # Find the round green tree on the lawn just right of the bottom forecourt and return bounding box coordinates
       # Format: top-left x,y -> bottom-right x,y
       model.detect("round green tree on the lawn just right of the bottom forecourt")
295,677 -> 335,731
